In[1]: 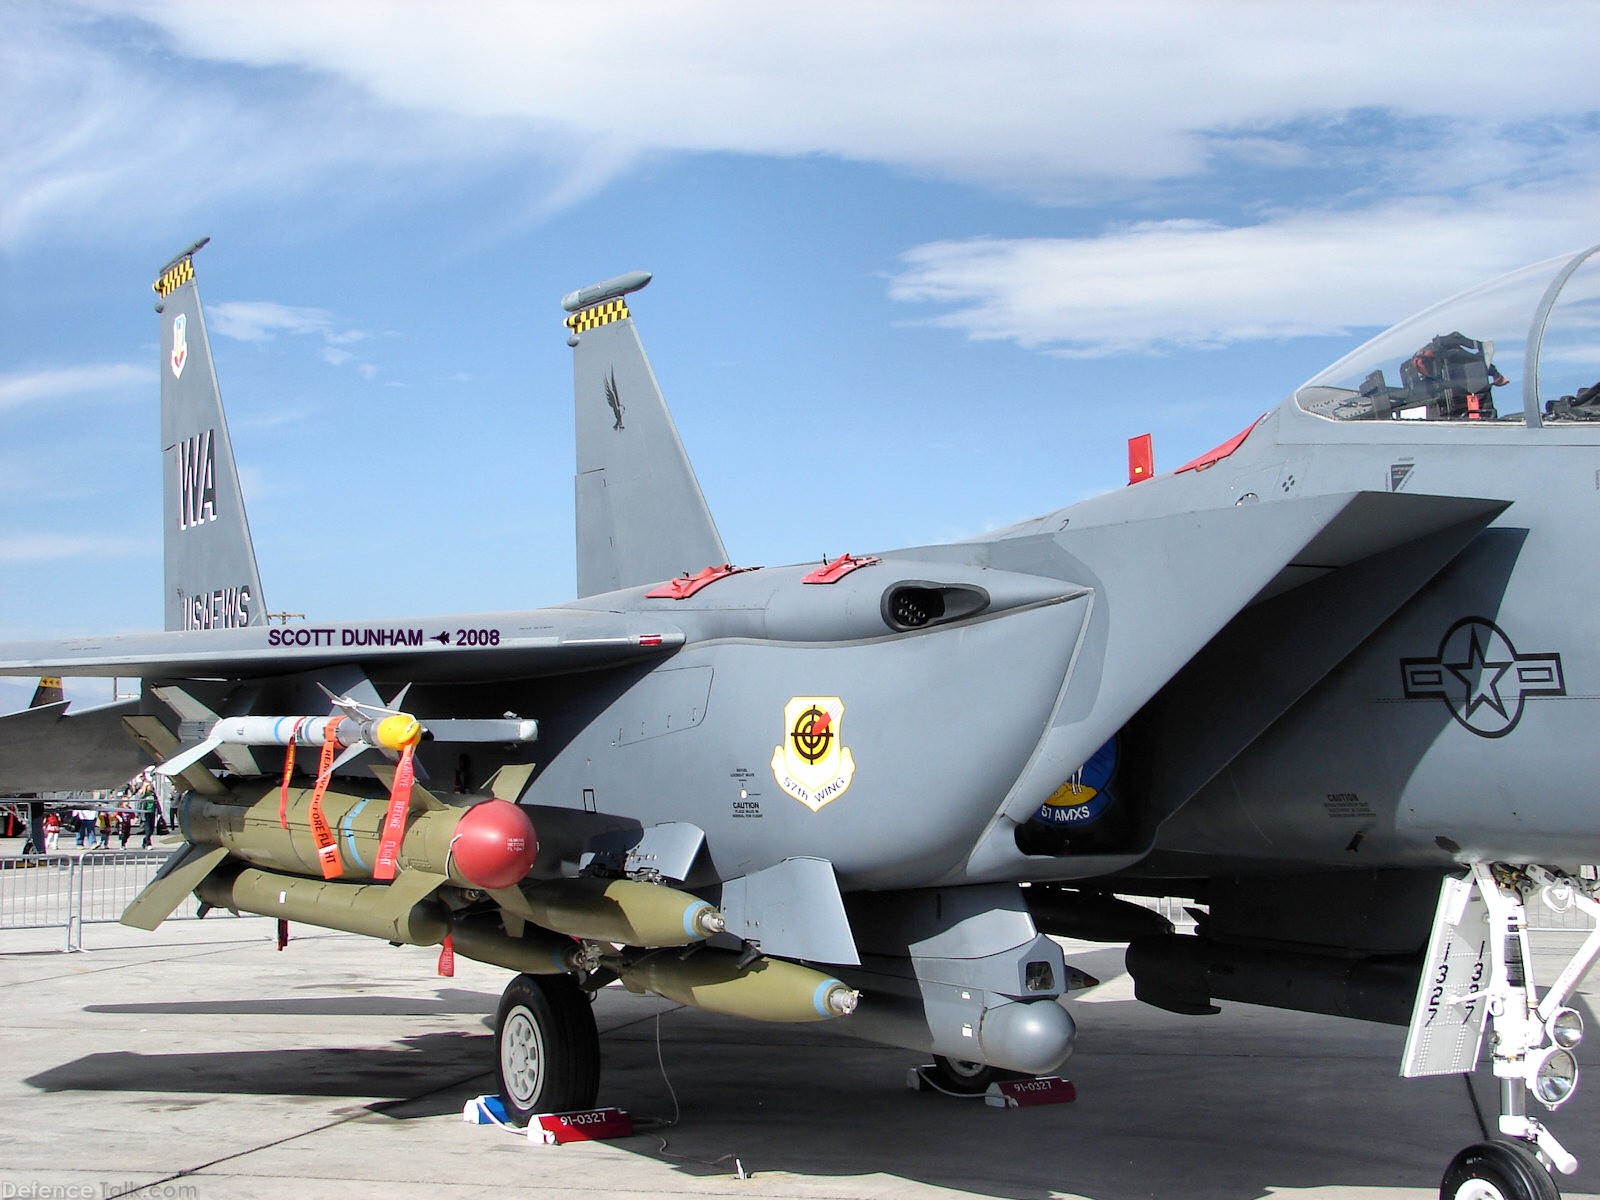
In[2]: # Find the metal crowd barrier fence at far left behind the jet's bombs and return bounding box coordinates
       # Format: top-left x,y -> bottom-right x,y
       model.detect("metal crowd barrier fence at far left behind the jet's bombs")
0,850 -> 262,950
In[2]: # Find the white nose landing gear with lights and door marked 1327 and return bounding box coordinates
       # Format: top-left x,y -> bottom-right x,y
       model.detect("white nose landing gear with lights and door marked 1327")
1402,864 -> 1600,1200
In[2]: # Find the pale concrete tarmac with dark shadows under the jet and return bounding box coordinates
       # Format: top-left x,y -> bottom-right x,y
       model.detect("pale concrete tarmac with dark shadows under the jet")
0,918 -> 1600,1200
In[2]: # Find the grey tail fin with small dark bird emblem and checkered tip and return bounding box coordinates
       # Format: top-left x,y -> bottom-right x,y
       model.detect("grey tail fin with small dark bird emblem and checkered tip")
562,278 -> 728,595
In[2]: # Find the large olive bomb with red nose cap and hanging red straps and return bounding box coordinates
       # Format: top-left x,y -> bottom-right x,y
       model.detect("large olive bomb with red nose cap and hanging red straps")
178,787 -> 539,890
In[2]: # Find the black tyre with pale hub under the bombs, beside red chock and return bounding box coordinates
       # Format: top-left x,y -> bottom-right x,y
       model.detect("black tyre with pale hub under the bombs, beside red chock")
494,974 -> 600,1125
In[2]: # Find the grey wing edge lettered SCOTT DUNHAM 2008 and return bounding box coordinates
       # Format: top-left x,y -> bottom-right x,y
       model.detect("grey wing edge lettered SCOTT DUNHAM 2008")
0,608 -> 685,682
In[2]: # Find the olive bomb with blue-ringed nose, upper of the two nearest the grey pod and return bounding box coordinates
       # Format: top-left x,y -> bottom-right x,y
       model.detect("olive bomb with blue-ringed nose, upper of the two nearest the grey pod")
523,878 -> 726,946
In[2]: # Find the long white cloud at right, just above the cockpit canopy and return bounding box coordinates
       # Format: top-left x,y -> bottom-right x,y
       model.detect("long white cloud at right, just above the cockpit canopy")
890,179 -> 1600,355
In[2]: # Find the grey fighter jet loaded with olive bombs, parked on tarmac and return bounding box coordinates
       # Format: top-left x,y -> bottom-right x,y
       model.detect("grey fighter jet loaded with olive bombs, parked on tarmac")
0,246 -> 1600,1200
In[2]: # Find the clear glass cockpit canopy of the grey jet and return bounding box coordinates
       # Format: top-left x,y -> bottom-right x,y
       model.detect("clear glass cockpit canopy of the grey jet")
1294,245 -> 1600,426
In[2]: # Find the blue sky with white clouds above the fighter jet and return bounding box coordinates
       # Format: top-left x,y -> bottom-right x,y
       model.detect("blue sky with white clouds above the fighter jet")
0,0 -> 1600,709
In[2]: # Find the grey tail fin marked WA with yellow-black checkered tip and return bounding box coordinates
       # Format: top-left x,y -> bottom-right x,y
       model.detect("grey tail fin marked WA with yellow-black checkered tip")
154,238 -> 267,640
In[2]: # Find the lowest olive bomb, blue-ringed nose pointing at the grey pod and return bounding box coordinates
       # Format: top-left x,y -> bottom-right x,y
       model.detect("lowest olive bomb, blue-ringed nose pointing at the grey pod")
618,950 -> 861,1022
